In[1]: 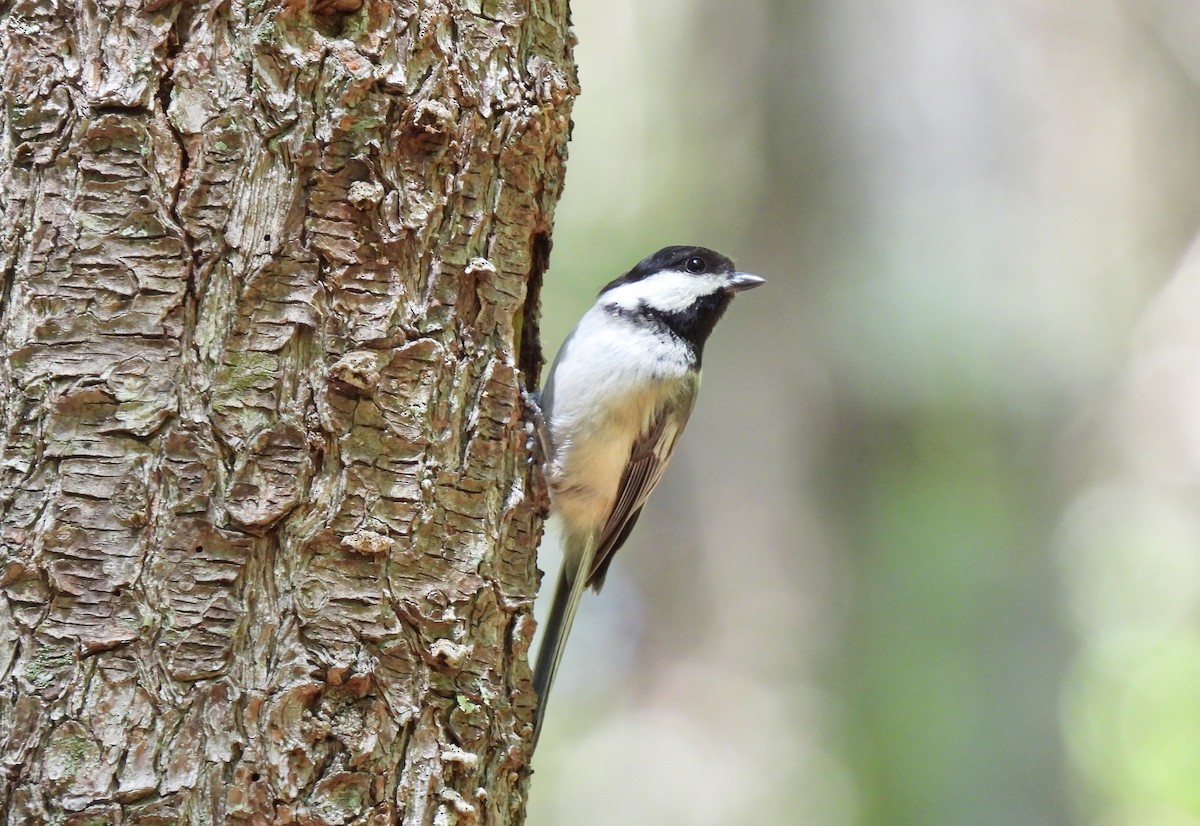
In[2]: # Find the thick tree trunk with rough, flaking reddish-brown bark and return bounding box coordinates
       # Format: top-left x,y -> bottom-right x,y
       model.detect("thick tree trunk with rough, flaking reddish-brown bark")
0,0 -> 575,825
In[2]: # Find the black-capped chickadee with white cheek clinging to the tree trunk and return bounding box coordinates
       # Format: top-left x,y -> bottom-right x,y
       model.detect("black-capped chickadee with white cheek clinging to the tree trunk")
534,246 -> 763,742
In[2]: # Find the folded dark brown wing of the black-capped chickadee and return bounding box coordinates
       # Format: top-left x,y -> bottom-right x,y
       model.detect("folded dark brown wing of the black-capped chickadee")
587,388 -> 695,591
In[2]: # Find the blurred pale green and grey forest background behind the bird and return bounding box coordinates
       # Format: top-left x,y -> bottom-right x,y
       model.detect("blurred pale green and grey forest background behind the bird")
528,0 -> 1200,826
